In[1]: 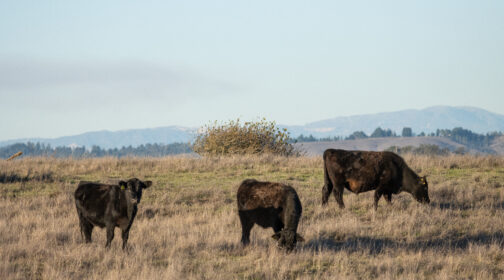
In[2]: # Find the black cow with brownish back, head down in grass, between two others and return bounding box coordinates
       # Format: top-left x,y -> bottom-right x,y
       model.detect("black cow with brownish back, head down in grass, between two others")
237,179 -> 304,251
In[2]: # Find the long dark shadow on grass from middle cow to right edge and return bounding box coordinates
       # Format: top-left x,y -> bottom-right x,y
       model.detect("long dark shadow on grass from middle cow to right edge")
298,232 -> 504,255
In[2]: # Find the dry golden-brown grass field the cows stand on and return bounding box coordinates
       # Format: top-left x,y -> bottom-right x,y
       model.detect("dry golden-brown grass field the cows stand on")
0,156 -> 504,279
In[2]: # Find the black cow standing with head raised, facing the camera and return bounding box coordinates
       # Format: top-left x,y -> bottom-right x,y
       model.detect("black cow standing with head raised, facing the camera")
75,178 -> 152,249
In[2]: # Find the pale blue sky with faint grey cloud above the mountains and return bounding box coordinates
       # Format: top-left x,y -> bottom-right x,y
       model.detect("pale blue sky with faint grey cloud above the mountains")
0,0 -> 504,140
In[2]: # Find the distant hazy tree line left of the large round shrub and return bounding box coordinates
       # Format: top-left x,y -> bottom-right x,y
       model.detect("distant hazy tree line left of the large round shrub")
0,142 -> 192,158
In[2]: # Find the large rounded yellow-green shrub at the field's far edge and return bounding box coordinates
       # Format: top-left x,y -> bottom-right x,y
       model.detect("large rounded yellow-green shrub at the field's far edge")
193,119 -> 298,156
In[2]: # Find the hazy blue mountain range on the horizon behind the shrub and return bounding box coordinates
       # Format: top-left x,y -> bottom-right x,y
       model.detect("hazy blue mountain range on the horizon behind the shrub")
0,106 -> 504,149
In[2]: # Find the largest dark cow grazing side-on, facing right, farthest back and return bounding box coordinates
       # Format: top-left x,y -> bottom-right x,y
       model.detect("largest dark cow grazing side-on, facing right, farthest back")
322,149 -> 430,210
